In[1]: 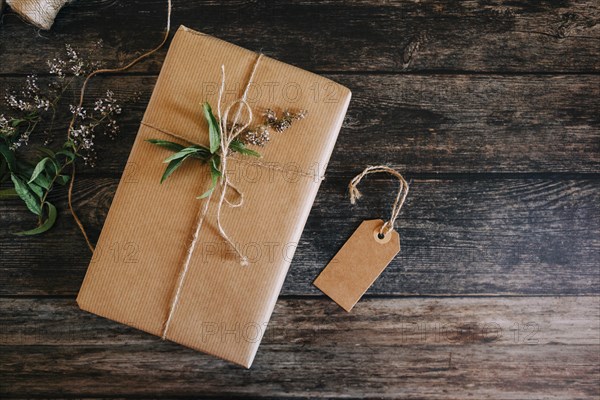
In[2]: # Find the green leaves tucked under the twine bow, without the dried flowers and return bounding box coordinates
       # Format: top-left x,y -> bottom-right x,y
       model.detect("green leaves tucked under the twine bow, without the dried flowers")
147,103 -> 260,199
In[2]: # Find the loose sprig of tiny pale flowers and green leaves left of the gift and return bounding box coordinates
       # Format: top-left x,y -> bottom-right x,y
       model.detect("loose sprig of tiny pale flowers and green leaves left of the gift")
0,45 -> 122,235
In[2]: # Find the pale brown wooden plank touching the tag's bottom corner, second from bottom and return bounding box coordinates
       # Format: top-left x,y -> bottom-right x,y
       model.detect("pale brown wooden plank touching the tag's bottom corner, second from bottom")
0,296 -> 600,348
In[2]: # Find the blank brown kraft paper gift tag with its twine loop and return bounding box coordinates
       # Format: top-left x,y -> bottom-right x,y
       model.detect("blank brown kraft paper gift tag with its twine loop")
314,166 -> 408,311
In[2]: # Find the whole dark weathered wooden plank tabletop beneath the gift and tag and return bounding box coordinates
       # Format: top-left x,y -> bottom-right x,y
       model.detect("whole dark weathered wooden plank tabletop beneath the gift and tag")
0,0 -> 600,399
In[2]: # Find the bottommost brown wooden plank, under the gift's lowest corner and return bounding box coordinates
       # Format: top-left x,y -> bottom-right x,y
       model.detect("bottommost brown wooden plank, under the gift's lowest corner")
0,344 -> 600,400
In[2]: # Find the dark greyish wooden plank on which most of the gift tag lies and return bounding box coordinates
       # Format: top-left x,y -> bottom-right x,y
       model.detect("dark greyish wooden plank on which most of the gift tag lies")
0,176 -> 600,295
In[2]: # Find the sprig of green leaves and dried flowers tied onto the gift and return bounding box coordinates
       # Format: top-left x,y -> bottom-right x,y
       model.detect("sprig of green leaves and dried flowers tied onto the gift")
147,103 -> 307,199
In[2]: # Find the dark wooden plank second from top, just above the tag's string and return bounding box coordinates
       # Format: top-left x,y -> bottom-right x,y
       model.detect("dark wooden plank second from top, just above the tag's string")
0,75 -> 600,176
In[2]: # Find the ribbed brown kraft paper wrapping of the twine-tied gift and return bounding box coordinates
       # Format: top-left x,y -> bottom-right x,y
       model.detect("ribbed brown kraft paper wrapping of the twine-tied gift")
77,26 -> 351,367
